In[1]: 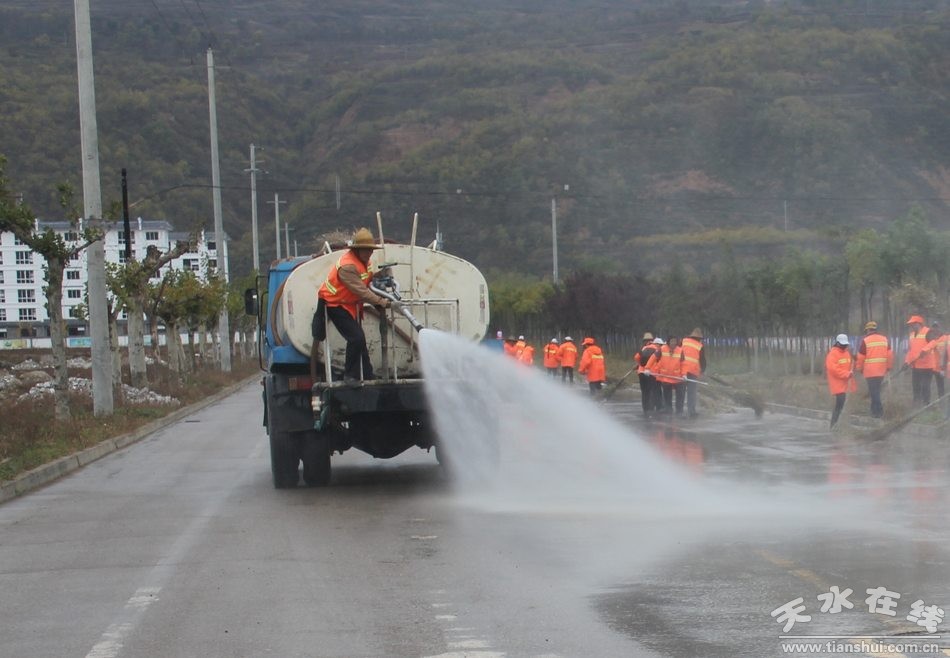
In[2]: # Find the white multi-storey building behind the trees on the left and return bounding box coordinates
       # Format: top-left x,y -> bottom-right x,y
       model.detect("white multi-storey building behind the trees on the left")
0,217 -> 218,338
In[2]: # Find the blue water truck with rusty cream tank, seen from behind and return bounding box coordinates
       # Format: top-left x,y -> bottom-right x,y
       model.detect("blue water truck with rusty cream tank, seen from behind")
245,217 -> 489,489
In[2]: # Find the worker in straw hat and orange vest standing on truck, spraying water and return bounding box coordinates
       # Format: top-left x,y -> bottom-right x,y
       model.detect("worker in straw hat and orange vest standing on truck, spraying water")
310,228 -> 390,383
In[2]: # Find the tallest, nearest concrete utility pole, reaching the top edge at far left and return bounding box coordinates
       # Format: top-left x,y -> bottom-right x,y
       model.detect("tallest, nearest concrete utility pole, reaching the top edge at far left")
73,0 -> 114,416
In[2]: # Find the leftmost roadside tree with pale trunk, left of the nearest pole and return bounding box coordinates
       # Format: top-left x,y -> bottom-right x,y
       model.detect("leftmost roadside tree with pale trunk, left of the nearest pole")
0,156 -> 102,420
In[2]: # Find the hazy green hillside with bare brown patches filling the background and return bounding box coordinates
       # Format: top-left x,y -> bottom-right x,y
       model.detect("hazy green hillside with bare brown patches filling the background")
0,0 -> 950,275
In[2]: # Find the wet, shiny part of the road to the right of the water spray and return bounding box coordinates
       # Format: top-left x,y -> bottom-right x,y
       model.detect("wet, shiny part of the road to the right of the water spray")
604,404 -> 950,656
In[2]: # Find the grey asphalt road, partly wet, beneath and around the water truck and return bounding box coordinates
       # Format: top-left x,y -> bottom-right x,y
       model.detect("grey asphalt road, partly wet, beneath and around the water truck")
0,385 -> 950,658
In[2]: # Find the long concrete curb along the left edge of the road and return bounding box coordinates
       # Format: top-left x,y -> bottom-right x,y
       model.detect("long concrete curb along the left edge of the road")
0,373 -> 261,504
